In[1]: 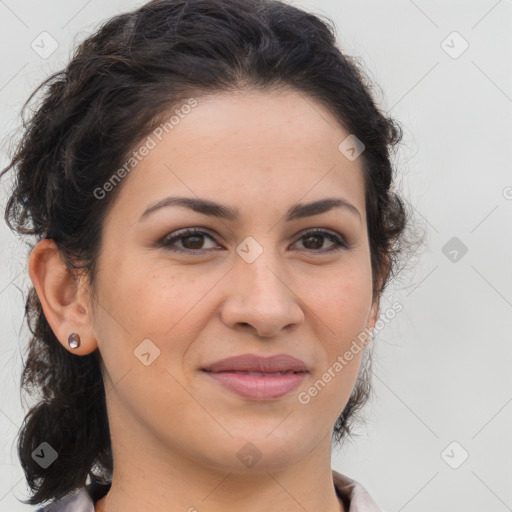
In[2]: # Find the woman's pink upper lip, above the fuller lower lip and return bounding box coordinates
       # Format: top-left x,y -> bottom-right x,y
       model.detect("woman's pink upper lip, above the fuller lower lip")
203,354 -> 308,375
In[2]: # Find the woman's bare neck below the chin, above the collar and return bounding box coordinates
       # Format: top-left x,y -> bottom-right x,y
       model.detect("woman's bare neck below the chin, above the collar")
95,438 -> 346,512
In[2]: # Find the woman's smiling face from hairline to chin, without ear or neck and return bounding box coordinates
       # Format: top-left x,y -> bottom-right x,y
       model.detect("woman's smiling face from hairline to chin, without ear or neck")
86,91 -> 377,471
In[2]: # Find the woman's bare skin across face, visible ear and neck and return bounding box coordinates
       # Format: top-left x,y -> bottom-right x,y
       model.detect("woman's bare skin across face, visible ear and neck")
29,90 -> 378,512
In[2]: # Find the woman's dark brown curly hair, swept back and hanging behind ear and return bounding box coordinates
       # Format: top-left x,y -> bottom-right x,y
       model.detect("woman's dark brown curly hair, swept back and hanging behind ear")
0,0 -> 409,504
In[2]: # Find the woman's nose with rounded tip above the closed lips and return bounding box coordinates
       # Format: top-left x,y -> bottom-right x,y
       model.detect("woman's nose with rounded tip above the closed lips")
221,246 -> 304,337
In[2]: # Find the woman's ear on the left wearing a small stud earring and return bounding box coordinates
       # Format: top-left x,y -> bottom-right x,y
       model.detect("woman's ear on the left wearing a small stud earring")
28,239 -> 97,355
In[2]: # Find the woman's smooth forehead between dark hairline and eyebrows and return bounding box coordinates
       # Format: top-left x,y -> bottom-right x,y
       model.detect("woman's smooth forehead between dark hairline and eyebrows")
109,90 -> 364,226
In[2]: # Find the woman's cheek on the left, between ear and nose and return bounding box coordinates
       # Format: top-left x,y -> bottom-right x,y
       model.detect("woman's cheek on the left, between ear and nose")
93,252 -> 219,384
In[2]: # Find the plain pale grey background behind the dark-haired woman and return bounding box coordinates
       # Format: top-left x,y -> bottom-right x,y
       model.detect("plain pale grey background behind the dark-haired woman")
0,0 -> 512,512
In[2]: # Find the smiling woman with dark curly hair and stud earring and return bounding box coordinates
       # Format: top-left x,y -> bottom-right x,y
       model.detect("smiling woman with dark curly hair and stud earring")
4,0 -> 407,512
